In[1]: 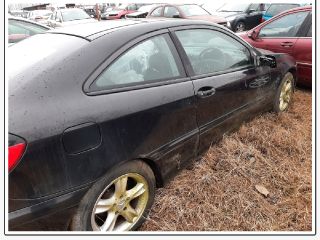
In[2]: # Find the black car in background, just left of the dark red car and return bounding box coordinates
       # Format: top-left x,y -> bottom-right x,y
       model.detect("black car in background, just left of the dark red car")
217,3 -> 266,32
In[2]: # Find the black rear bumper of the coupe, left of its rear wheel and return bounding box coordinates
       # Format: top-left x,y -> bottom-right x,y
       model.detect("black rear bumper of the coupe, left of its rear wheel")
9,186 -> 89,231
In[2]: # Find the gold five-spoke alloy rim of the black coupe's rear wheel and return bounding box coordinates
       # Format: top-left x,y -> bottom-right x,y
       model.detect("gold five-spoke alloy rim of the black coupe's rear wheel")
91,173 -> 149,232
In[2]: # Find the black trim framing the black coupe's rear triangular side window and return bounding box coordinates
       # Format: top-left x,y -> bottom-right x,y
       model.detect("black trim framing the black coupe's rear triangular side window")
83,29 -> 190,96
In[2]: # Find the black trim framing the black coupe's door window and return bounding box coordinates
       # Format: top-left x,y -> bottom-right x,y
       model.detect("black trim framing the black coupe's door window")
169,25 -> 256,80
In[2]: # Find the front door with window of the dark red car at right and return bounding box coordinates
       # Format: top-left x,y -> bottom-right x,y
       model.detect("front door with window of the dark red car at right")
254,11 -> 309,56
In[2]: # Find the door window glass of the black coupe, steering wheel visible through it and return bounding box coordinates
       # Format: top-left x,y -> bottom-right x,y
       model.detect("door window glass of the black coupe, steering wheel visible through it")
176,29 -> 252,75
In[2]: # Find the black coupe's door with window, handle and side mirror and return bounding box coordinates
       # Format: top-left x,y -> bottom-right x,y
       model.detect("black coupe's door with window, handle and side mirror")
172,27 -> 270,152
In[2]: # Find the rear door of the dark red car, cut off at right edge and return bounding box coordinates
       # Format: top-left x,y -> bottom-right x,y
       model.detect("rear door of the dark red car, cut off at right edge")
293,12 -> 312,86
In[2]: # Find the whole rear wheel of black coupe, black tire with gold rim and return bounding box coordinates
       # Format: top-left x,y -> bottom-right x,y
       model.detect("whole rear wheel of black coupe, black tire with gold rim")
70,160 -> 155,231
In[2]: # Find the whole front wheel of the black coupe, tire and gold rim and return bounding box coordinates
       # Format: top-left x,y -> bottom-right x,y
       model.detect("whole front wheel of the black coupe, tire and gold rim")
273,72 -> 294,113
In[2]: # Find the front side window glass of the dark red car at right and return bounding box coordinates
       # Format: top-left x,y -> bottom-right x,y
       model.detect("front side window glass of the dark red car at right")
259,11 -> 309,38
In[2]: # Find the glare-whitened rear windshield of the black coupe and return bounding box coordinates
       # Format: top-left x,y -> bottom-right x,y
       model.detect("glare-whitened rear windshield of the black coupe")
6,33 -> 88,78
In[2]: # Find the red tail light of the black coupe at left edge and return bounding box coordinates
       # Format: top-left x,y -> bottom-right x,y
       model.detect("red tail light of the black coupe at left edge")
8,134 -> 26,172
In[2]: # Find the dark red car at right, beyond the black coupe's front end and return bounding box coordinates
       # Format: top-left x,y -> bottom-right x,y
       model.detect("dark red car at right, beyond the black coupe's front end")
238,6 -> 312,87
